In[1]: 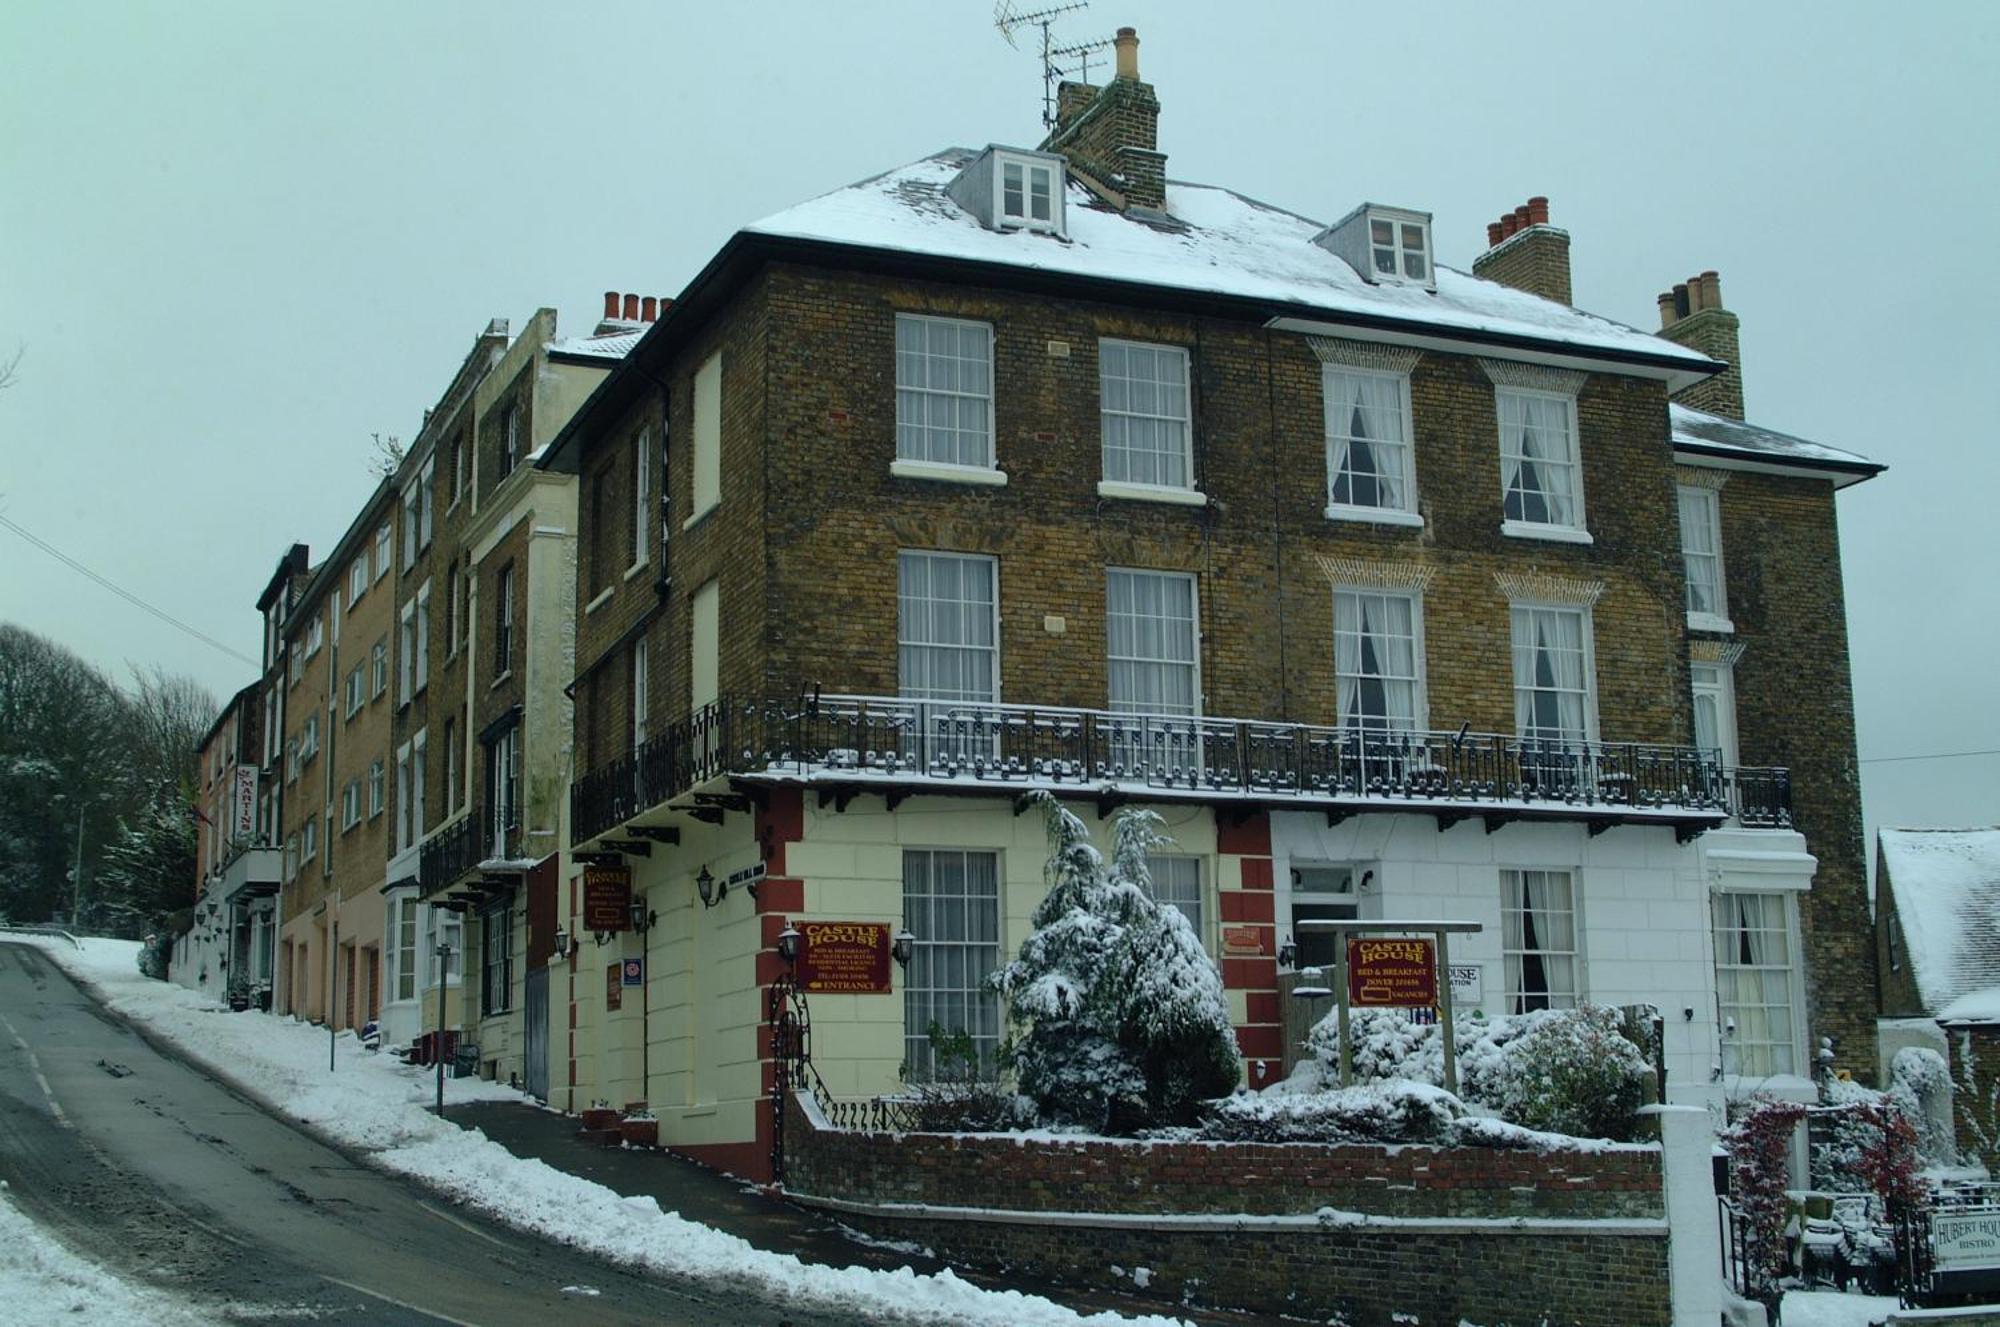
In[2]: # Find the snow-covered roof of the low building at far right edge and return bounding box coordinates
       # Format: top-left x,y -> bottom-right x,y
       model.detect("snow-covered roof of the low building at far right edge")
1880,829 -> 2000,1017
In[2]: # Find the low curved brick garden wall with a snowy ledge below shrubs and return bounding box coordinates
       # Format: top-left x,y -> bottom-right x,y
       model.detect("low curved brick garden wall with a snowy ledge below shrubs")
784,1101 -> 1672,1327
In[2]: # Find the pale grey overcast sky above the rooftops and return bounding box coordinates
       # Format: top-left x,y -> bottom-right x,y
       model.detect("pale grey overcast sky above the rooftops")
0,0 -> 2000,855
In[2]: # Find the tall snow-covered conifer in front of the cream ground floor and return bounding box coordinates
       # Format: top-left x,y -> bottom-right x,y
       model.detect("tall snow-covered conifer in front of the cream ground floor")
994,793 -> 1238,1133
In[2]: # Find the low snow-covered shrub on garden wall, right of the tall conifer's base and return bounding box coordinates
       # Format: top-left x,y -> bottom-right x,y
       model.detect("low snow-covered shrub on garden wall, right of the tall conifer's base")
1202,1079 -> 1466,1143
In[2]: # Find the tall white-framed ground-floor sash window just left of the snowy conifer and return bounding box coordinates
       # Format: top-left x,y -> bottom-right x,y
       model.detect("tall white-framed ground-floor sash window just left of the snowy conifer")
902,847 -> 1006,1081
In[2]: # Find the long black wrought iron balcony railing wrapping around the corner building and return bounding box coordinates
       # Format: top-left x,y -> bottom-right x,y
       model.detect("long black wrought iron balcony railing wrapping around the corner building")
570,695 -> 1792,843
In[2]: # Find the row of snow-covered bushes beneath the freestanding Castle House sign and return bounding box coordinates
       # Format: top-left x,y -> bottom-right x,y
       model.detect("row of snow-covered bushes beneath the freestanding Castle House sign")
1306,1005 -> 1652,1139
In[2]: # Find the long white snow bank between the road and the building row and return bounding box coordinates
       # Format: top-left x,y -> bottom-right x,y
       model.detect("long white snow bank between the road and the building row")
19,937 -> 1180,1327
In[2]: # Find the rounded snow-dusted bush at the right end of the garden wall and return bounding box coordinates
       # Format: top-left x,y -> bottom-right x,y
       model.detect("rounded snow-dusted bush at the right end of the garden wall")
1468,1005 -> 1652,1141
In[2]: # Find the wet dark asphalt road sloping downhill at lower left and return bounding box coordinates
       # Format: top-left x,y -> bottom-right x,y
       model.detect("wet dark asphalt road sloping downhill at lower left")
0,943 -> 872,1327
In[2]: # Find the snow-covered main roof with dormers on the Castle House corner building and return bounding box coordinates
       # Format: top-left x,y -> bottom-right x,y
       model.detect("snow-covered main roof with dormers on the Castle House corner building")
746,148 -> 1716,376
